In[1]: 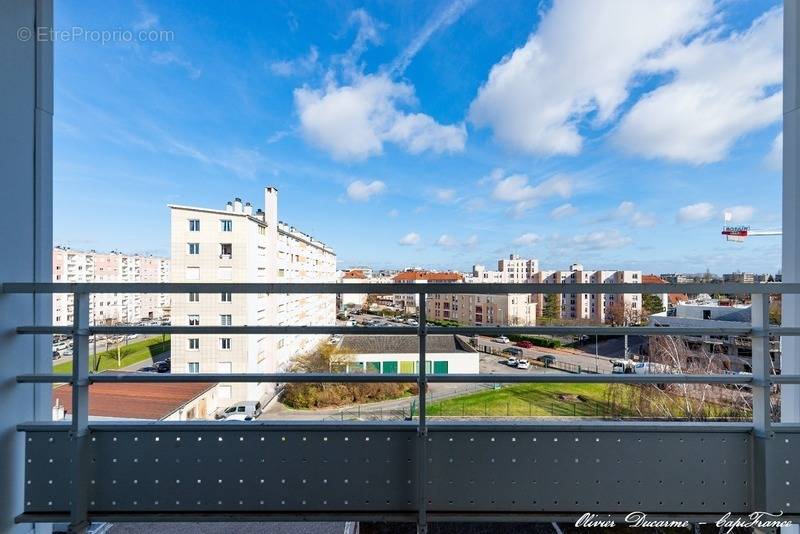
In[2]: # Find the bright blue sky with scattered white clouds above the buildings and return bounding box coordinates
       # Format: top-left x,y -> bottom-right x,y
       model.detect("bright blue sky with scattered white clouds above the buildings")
54,0 -> 782,272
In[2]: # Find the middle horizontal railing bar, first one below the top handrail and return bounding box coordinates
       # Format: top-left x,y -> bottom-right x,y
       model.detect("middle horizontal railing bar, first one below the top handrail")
17,325 -> 756,336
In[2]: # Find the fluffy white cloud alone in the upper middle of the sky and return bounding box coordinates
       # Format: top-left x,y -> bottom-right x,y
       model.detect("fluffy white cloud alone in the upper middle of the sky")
294,75 -> 467,160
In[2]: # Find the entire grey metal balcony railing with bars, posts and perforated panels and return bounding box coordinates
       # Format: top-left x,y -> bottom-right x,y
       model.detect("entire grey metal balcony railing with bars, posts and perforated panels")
0,283 -> 800,530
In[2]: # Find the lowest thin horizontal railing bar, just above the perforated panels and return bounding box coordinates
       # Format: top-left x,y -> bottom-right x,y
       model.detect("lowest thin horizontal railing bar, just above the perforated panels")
17,372 -> 780,385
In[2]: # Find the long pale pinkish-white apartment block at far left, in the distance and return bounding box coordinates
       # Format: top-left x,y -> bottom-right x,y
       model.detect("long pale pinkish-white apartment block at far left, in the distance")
53,247 -> 170,325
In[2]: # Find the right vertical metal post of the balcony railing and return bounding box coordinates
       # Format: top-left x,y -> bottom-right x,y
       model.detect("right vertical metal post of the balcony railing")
750,294 -> 772,511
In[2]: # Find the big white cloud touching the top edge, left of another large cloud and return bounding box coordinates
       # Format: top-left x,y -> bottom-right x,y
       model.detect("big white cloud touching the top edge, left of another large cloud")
469,0 -> 713,155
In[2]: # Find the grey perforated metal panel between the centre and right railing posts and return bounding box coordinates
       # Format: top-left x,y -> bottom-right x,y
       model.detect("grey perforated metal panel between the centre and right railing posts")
428,431 -> 751,515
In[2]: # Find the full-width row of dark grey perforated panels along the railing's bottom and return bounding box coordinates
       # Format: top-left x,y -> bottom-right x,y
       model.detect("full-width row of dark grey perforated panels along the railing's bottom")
25,425 -> 800,514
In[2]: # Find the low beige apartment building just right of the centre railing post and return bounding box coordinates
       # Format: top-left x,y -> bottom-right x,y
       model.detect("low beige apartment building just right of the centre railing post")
426,293 -> 536,326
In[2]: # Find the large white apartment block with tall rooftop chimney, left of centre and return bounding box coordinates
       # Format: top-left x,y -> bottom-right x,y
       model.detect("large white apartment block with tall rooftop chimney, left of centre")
169,187 -> 336,404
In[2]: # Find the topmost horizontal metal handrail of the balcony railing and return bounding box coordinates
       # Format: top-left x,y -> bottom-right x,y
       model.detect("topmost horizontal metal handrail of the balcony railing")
0,282 -> 800,295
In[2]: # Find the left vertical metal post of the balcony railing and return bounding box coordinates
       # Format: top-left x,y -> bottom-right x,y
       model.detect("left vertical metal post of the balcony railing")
69,293 -> 89,533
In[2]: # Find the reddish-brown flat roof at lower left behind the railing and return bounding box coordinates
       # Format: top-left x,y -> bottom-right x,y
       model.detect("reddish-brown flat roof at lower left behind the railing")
53,372 -> 216,419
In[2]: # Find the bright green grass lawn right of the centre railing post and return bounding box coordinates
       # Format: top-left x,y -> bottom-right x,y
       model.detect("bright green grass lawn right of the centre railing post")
428,384 -> 632,417
